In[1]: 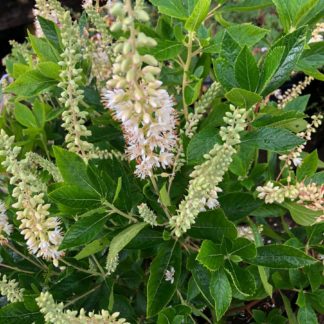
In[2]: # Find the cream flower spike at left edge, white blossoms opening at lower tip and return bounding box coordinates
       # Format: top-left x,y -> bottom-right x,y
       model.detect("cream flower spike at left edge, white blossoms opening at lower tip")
0,129 -> 62,265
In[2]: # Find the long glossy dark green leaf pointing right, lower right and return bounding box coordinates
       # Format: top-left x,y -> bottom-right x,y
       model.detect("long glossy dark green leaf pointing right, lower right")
249,244 -> 317,269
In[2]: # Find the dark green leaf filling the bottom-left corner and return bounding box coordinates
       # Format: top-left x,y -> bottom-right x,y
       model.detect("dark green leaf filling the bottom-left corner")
0,302 -> 42,324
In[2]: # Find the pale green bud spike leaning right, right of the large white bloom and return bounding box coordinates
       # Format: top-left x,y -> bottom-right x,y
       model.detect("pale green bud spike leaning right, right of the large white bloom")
170,106 -> 247,237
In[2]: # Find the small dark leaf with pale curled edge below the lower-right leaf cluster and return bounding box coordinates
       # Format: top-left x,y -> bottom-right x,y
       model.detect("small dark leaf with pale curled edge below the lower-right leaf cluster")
225,260 -> 256,296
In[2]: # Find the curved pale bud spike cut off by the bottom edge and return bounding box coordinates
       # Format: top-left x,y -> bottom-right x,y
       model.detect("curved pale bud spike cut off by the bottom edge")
36,292 -> 129,324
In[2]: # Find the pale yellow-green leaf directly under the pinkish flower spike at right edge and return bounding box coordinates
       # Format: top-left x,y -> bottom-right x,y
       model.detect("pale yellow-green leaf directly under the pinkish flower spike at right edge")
282,202 -> 323,226
